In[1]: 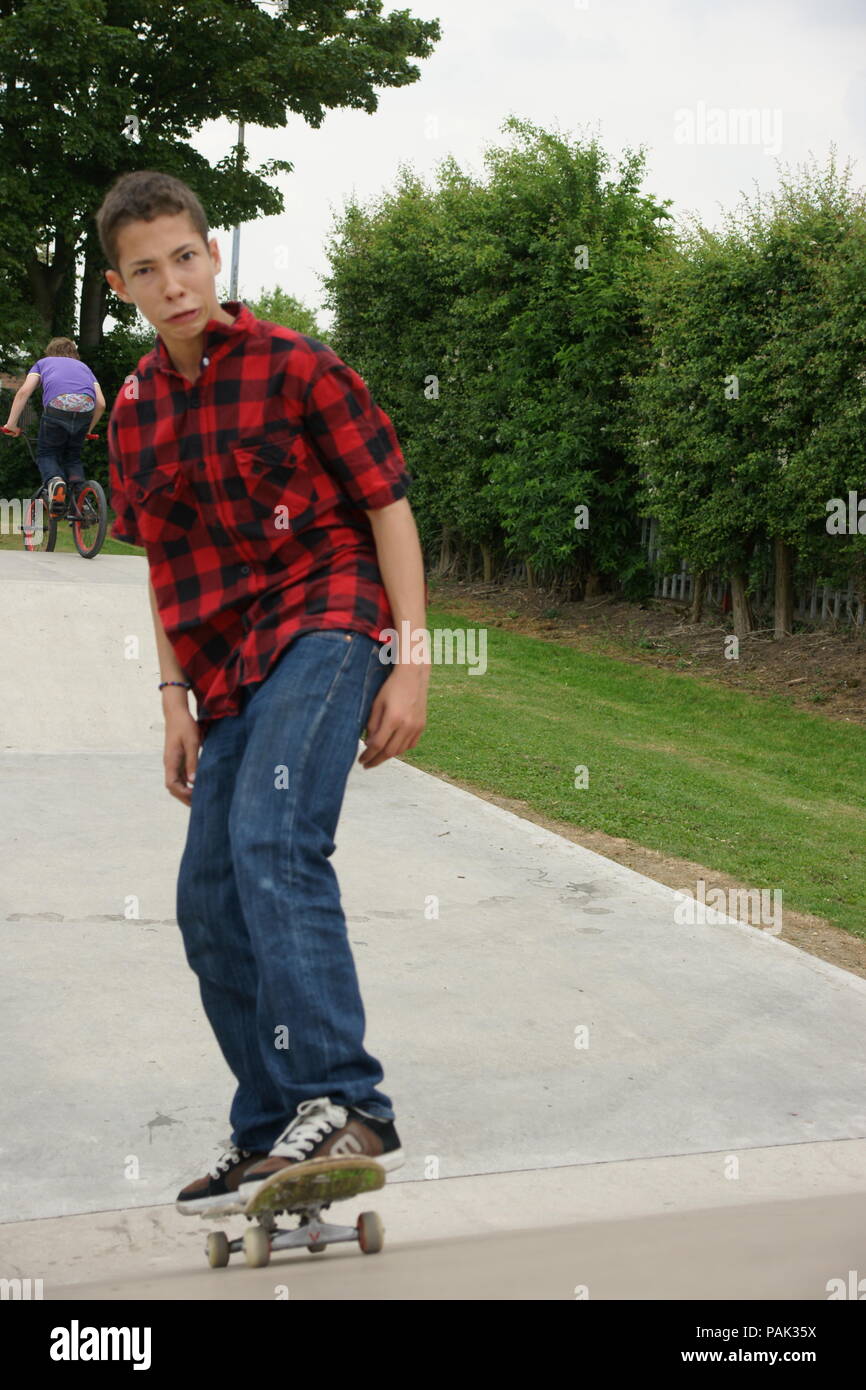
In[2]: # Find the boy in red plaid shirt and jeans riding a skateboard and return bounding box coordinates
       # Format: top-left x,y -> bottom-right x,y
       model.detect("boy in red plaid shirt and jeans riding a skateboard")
97,170 -> 430,1213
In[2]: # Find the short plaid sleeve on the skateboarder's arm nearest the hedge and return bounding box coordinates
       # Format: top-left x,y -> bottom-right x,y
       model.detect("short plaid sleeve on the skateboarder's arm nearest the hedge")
304,348 -> 411,510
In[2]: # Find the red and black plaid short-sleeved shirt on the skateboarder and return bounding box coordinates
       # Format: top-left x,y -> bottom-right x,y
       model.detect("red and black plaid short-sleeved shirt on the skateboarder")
108,300 -> 411,738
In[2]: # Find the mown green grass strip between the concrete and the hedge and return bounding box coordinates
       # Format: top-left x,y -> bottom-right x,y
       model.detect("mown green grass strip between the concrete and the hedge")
403,607 -> 866,937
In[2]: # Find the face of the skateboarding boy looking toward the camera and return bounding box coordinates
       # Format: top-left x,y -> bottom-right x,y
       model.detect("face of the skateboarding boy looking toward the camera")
106,213 -> 231,348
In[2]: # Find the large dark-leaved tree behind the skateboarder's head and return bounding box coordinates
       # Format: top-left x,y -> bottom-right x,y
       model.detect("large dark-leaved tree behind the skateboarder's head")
0,0 -> 441,360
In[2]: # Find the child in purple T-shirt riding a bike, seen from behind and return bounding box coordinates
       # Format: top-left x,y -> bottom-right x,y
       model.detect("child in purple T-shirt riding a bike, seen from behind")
6,338 -> 106,516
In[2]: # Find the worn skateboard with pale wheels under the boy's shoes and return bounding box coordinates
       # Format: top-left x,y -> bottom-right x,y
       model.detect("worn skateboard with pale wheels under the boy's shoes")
203,1158 -> 385,1269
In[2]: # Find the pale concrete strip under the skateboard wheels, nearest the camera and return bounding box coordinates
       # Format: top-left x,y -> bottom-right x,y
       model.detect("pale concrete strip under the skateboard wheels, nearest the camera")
0,1140 -> 866,1301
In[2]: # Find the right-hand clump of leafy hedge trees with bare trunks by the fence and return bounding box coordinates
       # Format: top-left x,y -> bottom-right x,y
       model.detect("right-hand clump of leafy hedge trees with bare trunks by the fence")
631,146 -> 866,637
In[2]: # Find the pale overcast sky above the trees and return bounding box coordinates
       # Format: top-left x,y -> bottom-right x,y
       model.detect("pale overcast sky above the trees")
180,0 -> 866,329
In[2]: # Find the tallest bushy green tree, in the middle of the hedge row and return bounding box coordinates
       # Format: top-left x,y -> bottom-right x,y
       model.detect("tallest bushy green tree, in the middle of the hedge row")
466,118 -> 666,598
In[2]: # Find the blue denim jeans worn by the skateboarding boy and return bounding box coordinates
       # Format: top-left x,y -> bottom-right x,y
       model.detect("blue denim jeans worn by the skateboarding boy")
177,630 -> 395,1152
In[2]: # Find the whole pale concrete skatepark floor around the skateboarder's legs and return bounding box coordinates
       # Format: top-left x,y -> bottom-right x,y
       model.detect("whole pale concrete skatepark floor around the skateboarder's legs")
0,552 -> 866,1298
